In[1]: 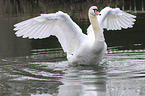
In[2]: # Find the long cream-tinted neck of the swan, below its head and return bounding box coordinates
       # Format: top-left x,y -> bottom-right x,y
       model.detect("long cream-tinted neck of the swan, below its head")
89,15 -> 104,39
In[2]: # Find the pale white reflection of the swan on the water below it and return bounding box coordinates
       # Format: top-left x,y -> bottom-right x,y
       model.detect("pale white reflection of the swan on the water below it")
58,63 -> 106,96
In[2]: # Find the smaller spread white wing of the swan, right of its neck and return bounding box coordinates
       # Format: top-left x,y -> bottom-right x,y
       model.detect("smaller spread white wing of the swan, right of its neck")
97,7 -> 136,30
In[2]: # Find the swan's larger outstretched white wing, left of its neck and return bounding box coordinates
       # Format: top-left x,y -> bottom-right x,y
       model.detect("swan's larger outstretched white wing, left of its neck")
14,11 -> 86,54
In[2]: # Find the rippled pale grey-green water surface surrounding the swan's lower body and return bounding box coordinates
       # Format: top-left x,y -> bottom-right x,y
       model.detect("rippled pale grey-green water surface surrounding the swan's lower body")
0,48 -> 145,96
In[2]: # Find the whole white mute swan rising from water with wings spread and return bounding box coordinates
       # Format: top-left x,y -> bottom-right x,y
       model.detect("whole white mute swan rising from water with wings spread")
14,6 -> 136,64
